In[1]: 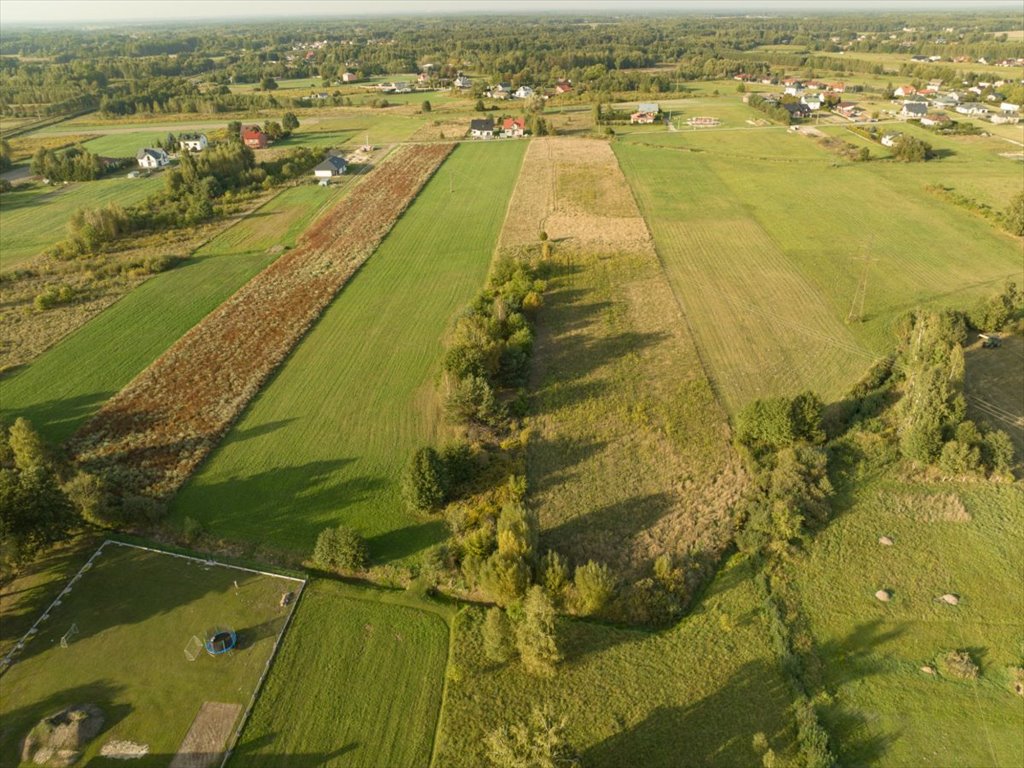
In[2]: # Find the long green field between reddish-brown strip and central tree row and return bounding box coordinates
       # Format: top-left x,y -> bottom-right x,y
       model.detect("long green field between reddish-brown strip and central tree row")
172,142 -> 525,561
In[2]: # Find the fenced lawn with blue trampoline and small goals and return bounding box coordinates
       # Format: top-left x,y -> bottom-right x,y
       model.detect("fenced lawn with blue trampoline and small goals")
0,544 -> 299,766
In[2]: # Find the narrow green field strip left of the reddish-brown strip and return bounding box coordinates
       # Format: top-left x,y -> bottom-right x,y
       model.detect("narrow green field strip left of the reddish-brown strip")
0,182 -> 348,442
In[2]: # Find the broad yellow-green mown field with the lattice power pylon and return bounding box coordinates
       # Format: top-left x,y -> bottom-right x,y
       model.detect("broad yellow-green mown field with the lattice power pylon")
614,129 -> 1024,411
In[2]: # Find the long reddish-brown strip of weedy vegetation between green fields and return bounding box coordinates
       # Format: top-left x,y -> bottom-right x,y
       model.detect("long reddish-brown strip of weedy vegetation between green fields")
71,144 -> 454,501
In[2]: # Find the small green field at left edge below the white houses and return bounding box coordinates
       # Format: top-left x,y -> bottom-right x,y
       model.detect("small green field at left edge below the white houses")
0,174 -> 164,269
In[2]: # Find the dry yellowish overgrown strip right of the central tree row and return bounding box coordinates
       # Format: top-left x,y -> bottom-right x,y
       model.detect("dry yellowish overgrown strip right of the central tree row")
502,139 -> 742,579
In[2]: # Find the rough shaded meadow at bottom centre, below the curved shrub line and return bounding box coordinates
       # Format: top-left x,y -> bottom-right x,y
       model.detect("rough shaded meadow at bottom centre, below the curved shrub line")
436,558 -> 795,768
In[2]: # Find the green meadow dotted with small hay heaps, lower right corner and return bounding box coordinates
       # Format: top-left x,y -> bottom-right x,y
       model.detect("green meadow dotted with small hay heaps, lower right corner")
792,477 -> 1024,768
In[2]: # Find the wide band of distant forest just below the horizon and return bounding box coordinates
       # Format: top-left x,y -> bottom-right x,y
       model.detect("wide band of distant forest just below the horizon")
0,13 -> 1024,118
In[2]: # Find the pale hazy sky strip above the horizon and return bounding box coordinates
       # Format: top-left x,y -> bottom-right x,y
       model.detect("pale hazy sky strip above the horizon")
0,0 -> 1021,25
